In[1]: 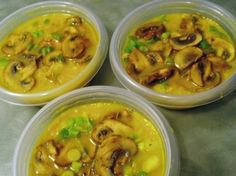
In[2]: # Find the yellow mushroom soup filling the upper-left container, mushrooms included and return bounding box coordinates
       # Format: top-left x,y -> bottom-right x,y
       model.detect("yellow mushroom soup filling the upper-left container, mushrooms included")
0,13 -> 99,93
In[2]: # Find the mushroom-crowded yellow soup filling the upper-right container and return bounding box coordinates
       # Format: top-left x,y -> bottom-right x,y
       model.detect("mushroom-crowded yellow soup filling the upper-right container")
121,13 -> 236,95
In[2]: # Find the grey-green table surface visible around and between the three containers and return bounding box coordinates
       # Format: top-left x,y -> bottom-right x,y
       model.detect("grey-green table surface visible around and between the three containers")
0,0 -> 236,176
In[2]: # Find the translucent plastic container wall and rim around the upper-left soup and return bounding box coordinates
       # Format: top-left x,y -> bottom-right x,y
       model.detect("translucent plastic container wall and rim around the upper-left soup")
0,1 -> 108,105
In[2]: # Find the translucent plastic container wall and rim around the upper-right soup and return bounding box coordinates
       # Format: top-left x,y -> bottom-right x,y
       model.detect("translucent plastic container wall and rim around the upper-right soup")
109,0 -> 236,109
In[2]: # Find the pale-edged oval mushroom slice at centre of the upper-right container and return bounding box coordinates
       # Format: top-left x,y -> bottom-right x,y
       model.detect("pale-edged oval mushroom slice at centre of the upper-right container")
174,47 -> 203,70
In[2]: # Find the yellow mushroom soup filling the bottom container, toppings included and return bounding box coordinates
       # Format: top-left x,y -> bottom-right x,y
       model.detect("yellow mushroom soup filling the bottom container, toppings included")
29,102 -> 166,176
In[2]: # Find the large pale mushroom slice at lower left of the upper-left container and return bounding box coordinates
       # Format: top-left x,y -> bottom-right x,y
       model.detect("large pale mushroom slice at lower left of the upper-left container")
4,61 -> 37,92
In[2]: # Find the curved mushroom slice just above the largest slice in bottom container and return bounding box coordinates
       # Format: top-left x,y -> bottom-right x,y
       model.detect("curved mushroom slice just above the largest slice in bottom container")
92,119 -> 132,144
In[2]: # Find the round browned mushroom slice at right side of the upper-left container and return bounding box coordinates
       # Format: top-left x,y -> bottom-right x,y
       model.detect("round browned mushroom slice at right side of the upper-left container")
62,35 -> 86,58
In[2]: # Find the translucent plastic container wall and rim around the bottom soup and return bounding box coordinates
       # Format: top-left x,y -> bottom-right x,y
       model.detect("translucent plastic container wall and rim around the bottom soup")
13,86 -> 179,176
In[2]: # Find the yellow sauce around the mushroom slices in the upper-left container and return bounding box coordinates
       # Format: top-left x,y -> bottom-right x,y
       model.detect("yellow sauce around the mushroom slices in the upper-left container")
0,13 -> 99,93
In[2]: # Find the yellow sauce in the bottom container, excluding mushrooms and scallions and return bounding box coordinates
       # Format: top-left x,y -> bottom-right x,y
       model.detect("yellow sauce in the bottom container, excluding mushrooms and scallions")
29,102 -> 166,176
